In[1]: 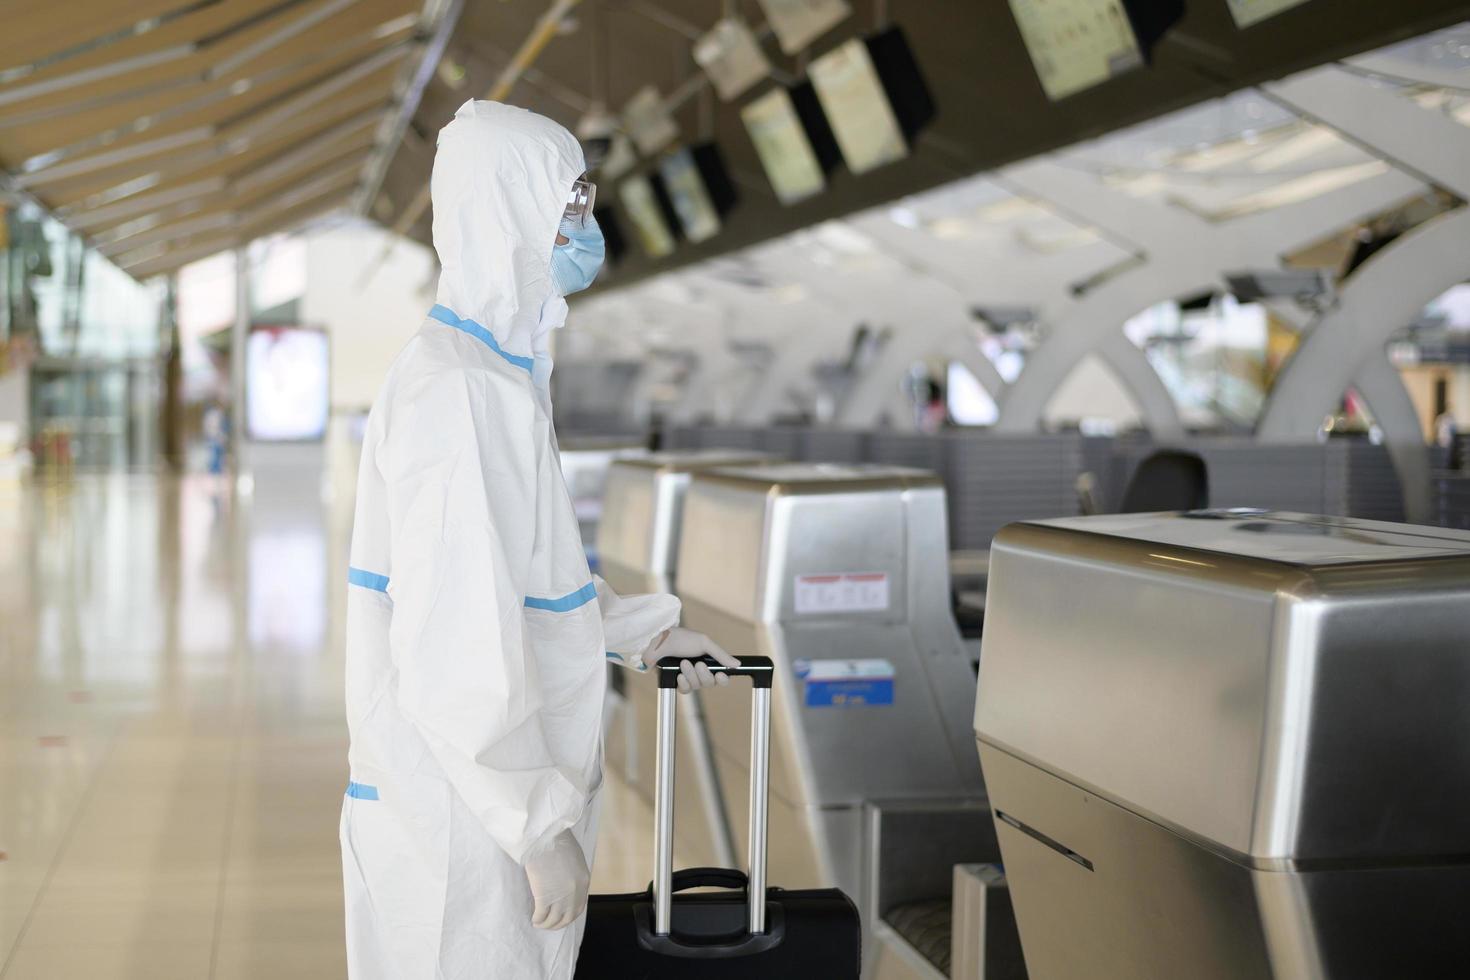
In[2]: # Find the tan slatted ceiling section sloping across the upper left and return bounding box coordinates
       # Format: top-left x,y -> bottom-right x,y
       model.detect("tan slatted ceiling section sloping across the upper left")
0,0 -> 425,276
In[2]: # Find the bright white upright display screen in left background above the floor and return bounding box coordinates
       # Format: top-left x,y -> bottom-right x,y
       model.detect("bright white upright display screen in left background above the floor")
245,326 -> 329,442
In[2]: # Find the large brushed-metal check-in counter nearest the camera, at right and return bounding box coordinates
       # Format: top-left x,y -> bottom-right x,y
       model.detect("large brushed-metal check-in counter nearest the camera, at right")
975,511 -> 1470,980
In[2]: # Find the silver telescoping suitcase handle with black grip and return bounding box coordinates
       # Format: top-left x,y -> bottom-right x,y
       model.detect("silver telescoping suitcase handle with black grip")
653,655 -> 776,936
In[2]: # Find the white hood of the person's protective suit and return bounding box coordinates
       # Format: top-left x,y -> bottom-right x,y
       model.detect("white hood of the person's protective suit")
429,100 -> 587,364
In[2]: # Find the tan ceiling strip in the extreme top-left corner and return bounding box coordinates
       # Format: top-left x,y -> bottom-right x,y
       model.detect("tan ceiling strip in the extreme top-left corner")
0,0 -> 202,71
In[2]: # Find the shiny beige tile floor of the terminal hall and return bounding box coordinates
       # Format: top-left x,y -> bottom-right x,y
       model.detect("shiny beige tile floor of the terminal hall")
0,475 -> 667,980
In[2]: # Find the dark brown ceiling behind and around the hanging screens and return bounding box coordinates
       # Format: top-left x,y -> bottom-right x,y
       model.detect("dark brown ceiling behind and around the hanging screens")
372,0 -> 1470,285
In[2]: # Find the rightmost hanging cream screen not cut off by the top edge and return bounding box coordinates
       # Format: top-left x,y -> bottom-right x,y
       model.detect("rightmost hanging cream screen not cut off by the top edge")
807,38 -> 908,173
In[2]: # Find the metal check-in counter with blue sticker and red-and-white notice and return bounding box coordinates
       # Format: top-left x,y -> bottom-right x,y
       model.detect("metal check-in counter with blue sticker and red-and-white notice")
676,463 -> 995,976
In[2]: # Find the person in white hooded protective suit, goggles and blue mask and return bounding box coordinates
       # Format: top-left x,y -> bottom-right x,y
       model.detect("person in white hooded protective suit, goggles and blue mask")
341,101 -> 736,980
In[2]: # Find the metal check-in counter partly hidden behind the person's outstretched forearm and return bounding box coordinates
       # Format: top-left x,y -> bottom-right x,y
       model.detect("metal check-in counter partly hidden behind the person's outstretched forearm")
597,450 -> 773,867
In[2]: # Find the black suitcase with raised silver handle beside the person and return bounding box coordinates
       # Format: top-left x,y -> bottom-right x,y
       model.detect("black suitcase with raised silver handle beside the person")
576,657 -> 863,980
